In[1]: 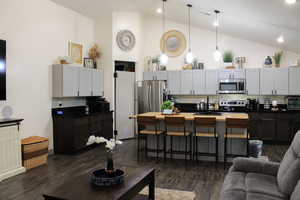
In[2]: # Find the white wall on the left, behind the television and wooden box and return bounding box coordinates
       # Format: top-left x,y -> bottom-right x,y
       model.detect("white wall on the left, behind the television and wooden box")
0,0 -> 95,147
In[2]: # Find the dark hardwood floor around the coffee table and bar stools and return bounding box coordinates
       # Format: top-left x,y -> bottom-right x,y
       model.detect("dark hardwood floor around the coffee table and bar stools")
0,140 -> 287,200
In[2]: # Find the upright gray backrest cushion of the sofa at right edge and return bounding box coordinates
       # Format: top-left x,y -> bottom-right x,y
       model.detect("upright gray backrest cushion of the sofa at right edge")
277,131 -> 300,195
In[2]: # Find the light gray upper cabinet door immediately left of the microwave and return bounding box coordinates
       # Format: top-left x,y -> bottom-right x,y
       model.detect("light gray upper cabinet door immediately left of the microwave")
205,70 -> 219,95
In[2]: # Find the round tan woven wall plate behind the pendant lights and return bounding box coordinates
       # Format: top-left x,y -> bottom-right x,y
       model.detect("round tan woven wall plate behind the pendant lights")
160,30 -> 186,57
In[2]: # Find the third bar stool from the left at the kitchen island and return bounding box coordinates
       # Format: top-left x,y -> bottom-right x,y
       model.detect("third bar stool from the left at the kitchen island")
194,117 -> 219,163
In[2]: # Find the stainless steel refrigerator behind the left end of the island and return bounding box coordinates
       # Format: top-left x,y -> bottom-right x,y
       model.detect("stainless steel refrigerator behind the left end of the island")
137,81 -> 166,114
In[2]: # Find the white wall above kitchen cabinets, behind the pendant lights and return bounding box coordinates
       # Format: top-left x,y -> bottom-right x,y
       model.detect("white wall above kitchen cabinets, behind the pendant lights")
143,17 -> 300,70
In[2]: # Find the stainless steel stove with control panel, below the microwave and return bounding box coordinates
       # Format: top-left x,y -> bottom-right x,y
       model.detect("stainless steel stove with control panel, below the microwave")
219,100 -> 247,112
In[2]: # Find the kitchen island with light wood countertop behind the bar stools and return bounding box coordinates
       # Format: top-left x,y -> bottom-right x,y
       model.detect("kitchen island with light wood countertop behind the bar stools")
130,112 -> 251,161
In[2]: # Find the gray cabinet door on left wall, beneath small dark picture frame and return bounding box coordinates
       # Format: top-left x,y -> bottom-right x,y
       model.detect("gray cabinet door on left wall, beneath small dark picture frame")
79,68 -> 93,97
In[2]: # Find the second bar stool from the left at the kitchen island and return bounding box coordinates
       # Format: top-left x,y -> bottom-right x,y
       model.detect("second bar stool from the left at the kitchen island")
164,116 -> 192,161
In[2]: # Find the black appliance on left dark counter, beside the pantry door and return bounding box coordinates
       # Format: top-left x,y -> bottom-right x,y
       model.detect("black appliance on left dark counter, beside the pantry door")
86,97 -> 110,113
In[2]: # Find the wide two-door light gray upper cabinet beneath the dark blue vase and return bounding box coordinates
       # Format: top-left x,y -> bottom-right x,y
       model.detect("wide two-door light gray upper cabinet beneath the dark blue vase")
260,68 -> 289,95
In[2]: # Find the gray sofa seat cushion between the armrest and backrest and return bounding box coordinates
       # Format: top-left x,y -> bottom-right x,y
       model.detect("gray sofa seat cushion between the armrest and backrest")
246,173 -> 286,199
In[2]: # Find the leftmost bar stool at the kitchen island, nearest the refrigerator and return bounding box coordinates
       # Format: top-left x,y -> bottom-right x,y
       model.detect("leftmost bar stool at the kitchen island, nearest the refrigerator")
137,116 -> 164,159
